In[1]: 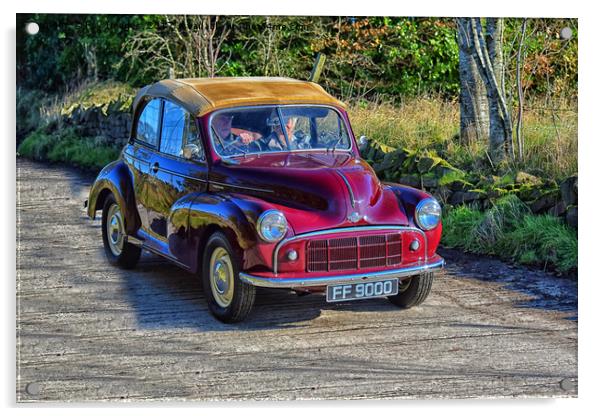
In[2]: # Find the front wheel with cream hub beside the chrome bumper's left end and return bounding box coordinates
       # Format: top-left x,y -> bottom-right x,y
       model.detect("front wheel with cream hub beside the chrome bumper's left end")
201,232 -> 255,323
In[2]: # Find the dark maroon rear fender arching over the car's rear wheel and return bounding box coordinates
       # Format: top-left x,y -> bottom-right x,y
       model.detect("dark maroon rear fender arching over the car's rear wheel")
88,160 -> 140,235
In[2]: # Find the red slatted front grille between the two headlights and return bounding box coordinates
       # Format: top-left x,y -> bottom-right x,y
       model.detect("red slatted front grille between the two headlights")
306,232 -> 402,272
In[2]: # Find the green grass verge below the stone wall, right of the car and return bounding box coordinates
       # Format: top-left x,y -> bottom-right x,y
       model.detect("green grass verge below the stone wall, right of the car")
441,195 -> 577,273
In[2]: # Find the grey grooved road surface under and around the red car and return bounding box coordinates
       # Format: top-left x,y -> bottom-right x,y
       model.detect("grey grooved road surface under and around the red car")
16,160 -> 577,402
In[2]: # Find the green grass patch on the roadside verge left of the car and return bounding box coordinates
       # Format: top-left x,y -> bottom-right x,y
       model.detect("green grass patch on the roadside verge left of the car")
17,129 -> 120,171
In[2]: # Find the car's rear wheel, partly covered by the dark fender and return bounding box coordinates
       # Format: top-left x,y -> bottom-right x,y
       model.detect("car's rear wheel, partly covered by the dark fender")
102,194 -> 141,269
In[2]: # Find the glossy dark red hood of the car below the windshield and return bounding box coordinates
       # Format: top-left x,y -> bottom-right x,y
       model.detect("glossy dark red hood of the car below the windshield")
209,152 -> 408,234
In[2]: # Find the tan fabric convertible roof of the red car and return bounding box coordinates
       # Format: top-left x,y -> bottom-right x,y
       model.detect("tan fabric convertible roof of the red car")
134,77 -> 344,116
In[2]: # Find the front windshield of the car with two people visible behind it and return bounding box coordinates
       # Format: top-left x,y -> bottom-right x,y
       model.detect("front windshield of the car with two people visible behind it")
211,106 -> 351,157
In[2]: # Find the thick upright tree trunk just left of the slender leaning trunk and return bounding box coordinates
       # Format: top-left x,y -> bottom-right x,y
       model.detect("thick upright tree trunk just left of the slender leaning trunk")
457,19 -> 489,143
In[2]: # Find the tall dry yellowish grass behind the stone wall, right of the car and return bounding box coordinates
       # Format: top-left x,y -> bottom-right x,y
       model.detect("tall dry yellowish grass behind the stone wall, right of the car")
349,97 -> 577,180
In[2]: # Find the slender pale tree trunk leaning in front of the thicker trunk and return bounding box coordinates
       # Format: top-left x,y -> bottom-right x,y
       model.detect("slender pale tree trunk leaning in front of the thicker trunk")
457,18 -> 514,163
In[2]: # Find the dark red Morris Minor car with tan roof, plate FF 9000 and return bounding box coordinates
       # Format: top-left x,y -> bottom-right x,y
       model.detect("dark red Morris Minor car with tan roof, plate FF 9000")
87,78 -> 444,322
